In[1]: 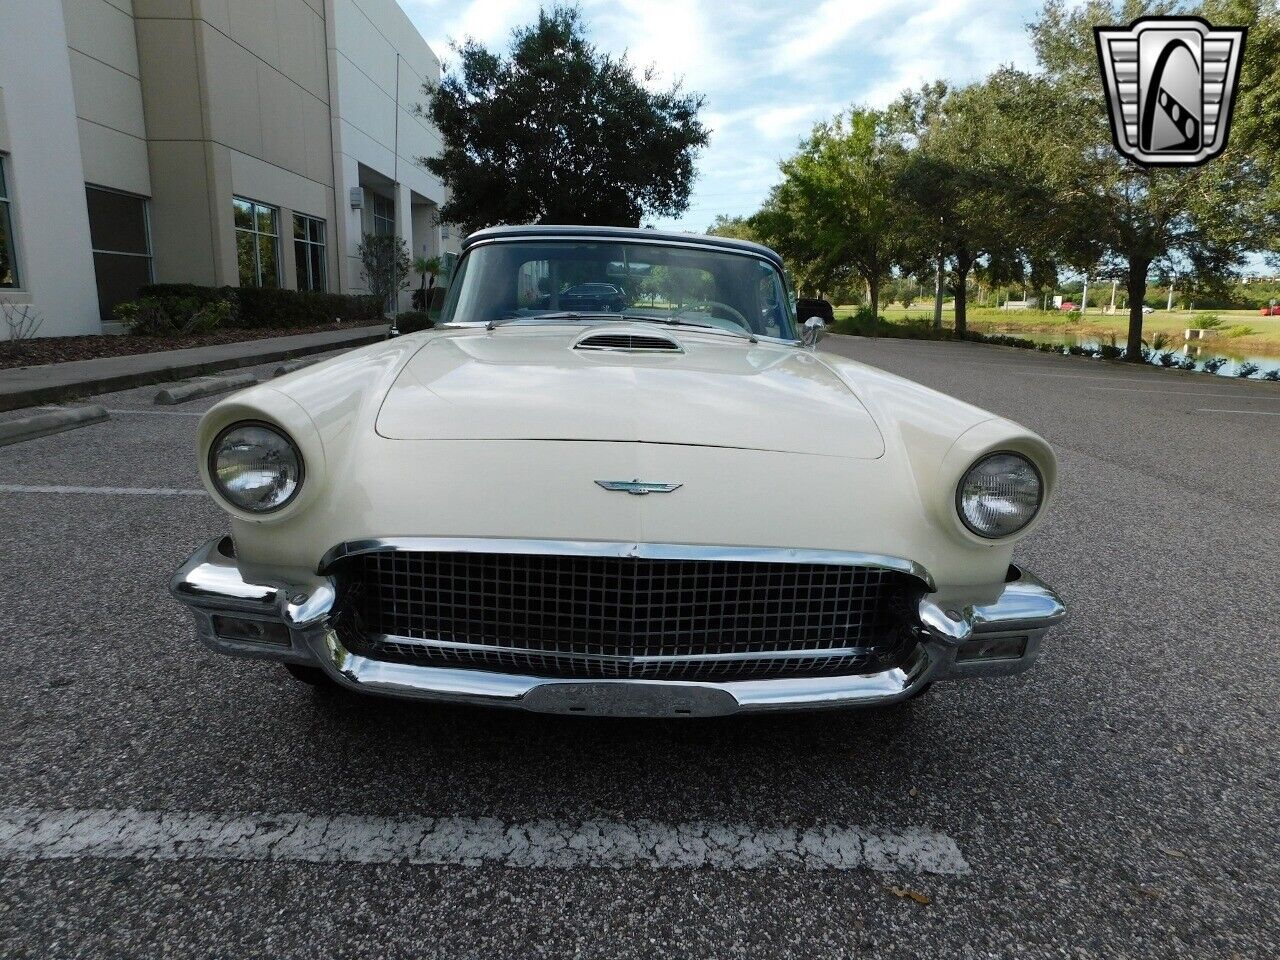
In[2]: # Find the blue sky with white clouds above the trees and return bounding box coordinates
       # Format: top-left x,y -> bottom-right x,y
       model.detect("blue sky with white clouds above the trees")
399,0 -> 1039,232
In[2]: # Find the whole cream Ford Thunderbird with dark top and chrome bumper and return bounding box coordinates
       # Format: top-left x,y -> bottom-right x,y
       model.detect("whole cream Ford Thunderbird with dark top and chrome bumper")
172,227 -> 1065,717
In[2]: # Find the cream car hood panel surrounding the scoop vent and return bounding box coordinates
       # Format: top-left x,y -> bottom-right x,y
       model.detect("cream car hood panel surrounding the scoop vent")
376,323 -> 884,460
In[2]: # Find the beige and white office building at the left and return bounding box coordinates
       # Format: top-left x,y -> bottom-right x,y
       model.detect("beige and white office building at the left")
0,0 -> 458,337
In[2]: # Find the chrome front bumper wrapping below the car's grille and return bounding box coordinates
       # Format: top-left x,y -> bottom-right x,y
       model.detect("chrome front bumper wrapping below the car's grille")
170,536 -> 1066,717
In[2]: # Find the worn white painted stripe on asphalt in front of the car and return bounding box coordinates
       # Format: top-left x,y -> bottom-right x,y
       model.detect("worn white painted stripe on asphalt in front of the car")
0,809 -> 969,874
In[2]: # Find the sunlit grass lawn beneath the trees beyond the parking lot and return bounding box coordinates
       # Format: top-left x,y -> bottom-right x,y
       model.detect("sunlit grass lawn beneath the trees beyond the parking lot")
836,302 -> 1280,358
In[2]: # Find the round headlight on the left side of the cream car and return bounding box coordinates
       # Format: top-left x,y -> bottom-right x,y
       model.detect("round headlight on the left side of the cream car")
209,422 -> 302,513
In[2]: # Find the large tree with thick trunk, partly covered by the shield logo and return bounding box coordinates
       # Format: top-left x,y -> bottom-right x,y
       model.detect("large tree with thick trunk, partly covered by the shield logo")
1030,0 -> 1266,362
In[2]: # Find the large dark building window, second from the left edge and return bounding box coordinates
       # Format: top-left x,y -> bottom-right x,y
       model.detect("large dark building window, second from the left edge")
84,187 -> 152,323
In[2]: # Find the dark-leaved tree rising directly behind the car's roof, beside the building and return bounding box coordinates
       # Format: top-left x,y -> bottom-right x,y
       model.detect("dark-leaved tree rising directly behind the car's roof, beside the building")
419,6 -> 708,229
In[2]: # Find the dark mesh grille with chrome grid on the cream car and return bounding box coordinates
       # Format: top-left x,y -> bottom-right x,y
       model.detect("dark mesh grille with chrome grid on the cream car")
339,552 -> 919,680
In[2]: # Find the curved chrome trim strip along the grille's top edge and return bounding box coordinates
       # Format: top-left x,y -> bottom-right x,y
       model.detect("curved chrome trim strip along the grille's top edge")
317,536 -> 937,591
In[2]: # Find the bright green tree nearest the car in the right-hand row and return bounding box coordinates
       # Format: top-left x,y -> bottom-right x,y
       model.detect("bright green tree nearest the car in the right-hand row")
753,109 -> 904,330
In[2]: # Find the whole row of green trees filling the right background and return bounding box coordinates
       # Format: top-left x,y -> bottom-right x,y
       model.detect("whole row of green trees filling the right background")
732,0 -> 1280,360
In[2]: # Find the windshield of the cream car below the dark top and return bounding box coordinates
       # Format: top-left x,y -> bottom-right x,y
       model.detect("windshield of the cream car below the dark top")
440,241 -> 795,339
